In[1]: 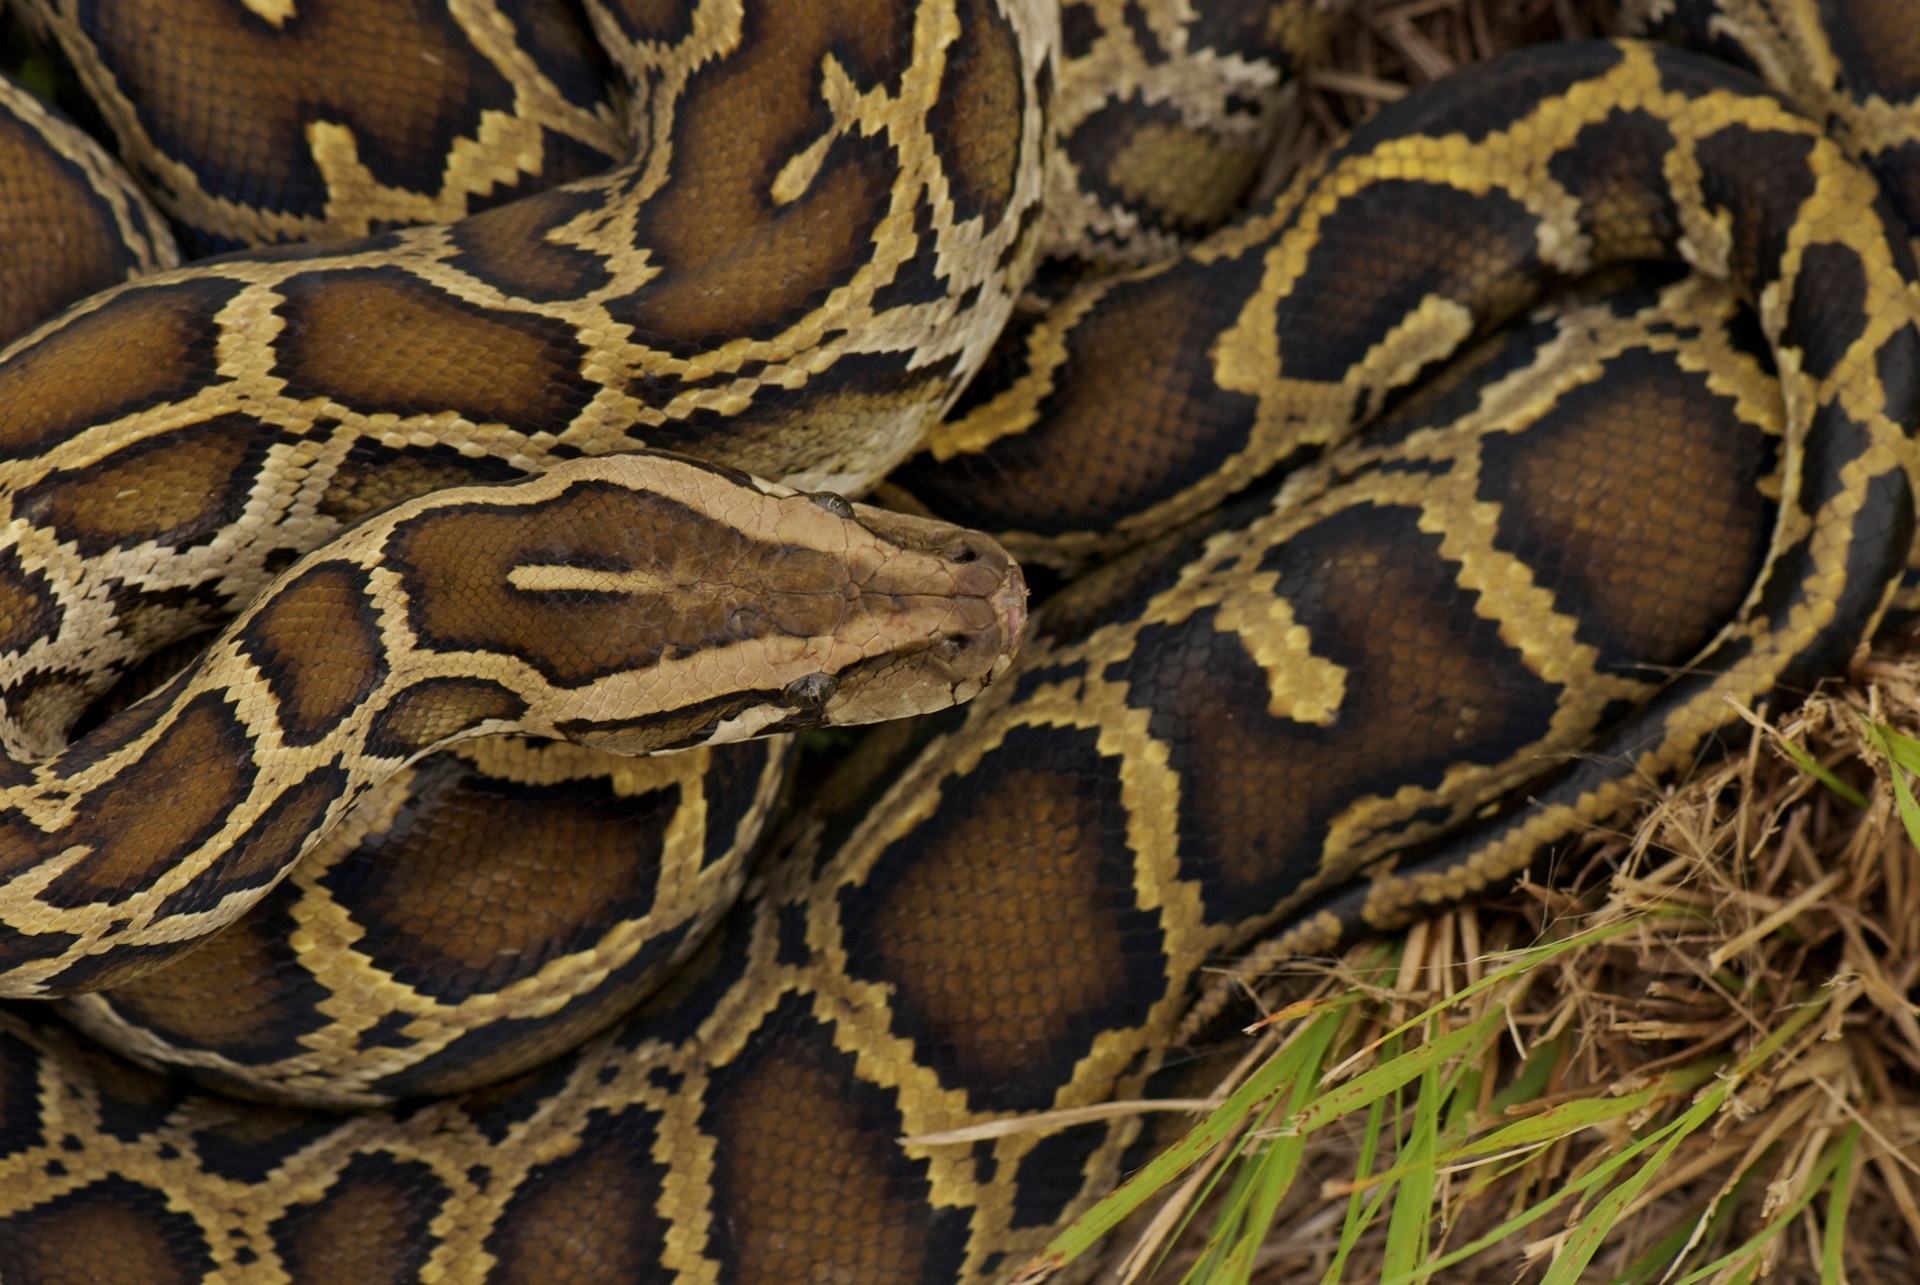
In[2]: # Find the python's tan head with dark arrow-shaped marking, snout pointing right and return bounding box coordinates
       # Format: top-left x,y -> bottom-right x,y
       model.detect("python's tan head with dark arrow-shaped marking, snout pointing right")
435,455 -> 1027,755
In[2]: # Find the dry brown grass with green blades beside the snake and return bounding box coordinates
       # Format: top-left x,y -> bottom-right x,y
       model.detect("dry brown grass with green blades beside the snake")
1052,638 -> 1920,1285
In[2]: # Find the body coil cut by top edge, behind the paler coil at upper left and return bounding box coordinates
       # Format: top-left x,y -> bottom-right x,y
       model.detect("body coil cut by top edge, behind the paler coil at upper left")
19,0 -> 630,259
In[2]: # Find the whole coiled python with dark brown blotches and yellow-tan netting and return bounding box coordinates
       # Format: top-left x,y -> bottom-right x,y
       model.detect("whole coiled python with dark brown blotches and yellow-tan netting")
0,0 -> 1920,1283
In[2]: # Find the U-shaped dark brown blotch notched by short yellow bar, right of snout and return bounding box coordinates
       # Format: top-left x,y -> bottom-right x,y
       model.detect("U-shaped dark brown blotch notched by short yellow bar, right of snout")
1106,505 -> 1559,924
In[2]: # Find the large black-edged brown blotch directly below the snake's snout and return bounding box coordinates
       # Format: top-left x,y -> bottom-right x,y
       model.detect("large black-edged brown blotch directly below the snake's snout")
839,728 -> 1165,1110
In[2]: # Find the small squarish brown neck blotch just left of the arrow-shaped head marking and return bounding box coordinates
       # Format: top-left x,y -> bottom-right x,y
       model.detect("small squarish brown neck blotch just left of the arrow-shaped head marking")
238,563 -> 388,745
